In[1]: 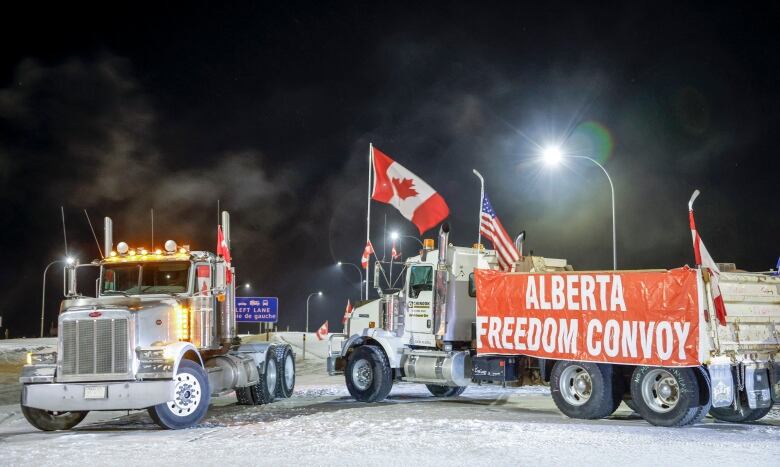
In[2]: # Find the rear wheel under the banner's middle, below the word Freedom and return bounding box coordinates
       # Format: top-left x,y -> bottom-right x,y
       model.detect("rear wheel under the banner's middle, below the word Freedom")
550,360 -> 622,420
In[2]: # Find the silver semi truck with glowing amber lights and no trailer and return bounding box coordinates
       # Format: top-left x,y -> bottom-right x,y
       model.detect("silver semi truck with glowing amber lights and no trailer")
20,211 -> 295,431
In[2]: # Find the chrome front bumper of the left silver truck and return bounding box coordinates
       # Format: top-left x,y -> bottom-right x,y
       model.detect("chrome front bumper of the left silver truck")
22,380 -> 175,412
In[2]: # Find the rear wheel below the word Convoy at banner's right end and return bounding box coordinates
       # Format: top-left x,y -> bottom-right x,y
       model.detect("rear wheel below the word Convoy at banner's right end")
631,366 -> 703,427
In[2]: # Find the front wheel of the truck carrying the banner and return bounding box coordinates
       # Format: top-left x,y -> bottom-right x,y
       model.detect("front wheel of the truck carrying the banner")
344,345 -> 393,402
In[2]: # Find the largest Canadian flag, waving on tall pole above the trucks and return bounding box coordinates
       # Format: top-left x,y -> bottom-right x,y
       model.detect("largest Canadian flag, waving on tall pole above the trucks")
371,146 -> 450,234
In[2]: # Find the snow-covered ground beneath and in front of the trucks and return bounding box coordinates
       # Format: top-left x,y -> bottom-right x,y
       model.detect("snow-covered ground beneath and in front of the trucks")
0,333 -> 780,466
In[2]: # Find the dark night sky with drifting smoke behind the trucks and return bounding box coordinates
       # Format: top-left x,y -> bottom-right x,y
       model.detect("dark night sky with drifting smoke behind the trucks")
0,2 -> 780,335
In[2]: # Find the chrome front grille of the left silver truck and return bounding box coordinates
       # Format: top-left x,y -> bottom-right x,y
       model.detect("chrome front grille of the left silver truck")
62,318 -> 128,376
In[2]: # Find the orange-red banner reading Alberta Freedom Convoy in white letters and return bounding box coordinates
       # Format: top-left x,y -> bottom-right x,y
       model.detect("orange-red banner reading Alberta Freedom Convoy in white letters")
475,267 -> 700,366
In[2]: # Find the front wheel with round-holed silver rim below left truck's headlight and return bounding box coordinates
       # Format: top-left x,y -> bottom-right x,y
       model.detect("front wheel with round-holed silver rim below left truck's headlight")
148,360 -> 211,430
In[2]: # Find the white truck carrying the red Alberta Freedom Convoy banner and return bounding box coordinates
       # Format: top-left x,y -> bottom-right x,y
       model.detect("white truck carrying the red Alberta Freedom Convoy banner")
327,224 -> 780,427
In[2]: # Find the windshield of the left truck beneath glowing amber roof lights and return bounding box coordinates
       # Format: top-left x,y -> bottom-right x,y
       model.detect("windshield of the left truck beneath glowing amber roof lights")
100,261 -> 190,295
